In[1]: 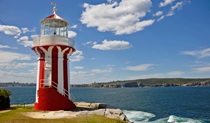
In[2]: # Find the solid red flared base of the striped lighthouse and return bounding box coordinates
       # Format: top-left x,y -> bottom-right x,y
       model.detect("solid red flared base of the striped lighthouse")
34,88 -> 76,111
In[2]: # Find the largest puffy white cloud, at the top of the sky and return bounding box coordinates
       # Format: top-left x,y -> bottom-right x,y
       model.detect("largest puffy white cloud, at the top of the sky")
80,0 -> 154,35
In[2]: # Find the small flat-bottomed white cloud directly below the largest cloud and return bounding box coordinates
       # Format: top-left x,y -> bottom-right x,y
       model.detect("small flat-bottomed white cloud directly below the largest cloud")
92,40 -> 132,50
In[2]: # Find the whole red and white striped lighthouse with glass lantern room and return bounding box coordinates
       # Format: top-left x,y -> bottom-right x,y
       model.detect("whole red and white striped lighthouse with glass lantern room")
32,7 -> 76,111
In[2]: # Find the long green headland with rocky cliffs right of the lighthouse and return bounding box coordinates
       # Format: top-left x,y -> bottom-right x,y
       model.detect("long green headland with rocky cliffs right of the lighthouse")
72,78 -> 210,88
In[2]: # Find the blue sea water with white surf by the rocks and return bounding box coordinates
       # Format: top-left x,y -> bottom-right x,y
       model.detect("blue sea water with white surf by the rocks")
2,87 -> 210,123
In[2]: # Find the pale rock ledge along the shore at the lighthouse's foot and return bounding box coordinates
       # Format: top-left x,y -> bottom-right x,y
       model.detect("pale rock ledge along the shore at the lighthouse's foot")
23,102 -> 129,122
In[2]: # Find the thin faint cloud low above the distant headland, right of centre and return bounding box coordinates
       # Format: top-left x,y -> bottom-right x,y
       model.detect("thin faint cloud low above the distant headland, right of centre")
124,64 -> 155,71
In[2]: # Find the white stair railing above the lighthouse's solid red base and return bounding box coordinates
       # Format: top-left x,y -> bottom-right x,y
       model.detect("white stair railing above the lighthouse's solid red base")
39,79 -> 70,98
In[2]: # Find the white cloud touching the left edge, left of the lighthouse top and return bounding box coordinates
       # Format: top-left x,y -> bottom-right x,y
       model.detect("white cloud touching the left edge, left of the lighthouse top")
0,25 -> 21,38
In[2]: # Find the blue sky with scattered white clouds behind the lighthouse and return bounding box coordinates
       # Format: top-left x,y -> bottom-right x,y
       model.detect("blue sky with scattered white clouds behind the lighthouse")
0,0 -> 210,84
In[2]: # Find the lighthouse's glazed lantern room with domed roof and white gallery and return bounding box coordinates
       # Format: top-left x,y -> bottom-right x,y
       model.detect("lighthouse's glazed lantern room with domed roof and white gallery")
33,7 -> 74,47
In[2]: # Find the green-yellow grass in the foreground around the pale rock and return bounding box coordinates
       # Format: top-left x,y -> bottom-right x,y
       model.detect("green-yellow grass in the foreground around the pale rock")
0,106 -> 126,123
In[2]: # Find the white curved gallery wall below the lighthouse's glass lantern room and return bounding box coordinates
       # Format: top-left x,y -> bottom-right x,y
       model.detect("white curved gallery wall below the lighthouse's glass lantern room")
33,35 -> 74,47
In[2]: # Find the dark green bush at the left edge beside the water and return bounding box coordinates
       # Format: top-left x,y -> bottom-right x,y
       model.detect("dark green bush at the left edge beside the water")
0,89 -> 11,110
